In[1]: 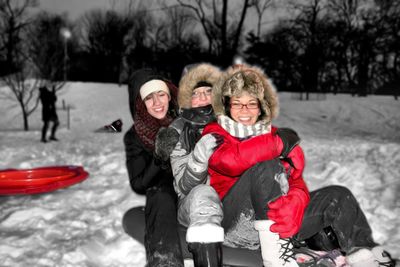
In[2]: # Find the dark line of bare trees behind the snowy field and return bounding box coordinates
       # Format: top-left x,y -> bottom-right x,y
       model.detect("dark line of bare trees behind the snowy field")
0,0 -> 400,96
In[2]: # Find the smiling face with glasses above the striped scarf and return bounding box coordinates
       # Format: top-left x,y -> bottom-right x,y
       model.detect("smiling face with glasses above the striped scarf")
230,91 -> 261,126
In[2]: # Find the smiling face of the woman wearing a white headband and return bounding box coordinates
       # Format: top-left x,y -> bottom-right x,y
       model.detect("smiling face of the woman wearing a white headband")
143,91 -> 170,120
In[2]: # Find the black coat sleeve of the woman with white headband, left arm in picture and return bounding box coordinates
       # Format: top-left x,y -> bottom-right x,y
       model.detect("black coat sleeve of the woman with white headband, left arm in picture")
124,128 -> 161,194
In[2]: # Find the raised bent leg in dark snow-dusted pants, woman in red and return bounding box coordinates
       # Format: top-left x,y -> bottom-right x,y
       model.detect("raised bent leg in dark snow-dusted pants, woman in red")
222,160 -> 285,249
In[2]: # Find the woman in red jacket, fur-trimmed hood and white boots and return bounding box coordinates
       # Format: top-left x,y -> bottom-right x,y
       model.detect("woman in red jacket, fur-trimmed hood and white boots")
199,65 -> 391,267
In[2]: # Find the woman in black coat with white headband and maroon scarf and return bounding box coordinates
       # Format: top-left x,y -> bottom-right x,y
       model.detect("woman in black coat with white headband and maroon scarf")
123,69 -> 183,267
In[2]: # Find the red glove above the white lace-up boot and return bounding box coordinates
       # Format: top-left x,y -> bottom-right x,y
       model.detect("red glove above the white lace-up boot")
267,188 -> 309,238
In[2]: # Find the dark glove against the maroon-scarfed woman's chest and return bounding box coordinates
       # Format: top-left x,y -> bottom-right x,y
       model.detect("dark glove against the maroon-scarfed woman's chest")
154,127 -> 179,162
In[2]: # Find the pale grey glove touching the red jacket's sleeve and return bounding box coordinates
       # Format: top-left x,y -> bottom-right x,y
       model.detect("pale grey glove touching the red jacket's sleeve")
188,134 -> 222,172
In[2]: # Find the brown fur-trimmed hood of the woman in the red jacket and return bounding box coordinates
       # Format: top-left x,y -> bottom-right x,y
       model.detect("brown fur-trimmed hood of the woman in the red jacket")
212,64 -> 279,124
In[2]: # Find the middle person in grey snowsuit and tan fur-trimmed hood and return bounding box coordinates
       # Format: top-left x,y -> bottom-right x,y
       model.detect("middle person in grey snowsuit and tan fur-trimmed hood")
156,63 -> 224,267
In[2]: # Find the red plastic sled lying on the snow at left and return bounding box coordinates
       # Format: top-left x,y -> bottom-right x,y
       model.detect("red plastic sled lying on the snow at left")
0,165 -> 89,195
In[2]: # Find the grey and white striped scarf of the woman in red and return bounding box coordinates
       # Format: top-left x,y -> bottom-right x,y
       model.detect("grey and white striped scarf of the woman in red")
218,115 -> 271,139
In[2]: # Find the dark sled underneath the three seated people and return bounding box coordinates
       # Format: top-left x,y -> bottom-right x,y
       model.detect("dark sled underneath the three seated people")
123,206 -> 263,267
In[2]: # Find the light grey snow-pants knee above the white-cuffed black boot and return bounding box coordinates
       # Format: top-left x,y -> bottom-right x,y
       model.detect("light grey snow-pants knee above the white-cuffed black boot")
178,184 -> 223,230
